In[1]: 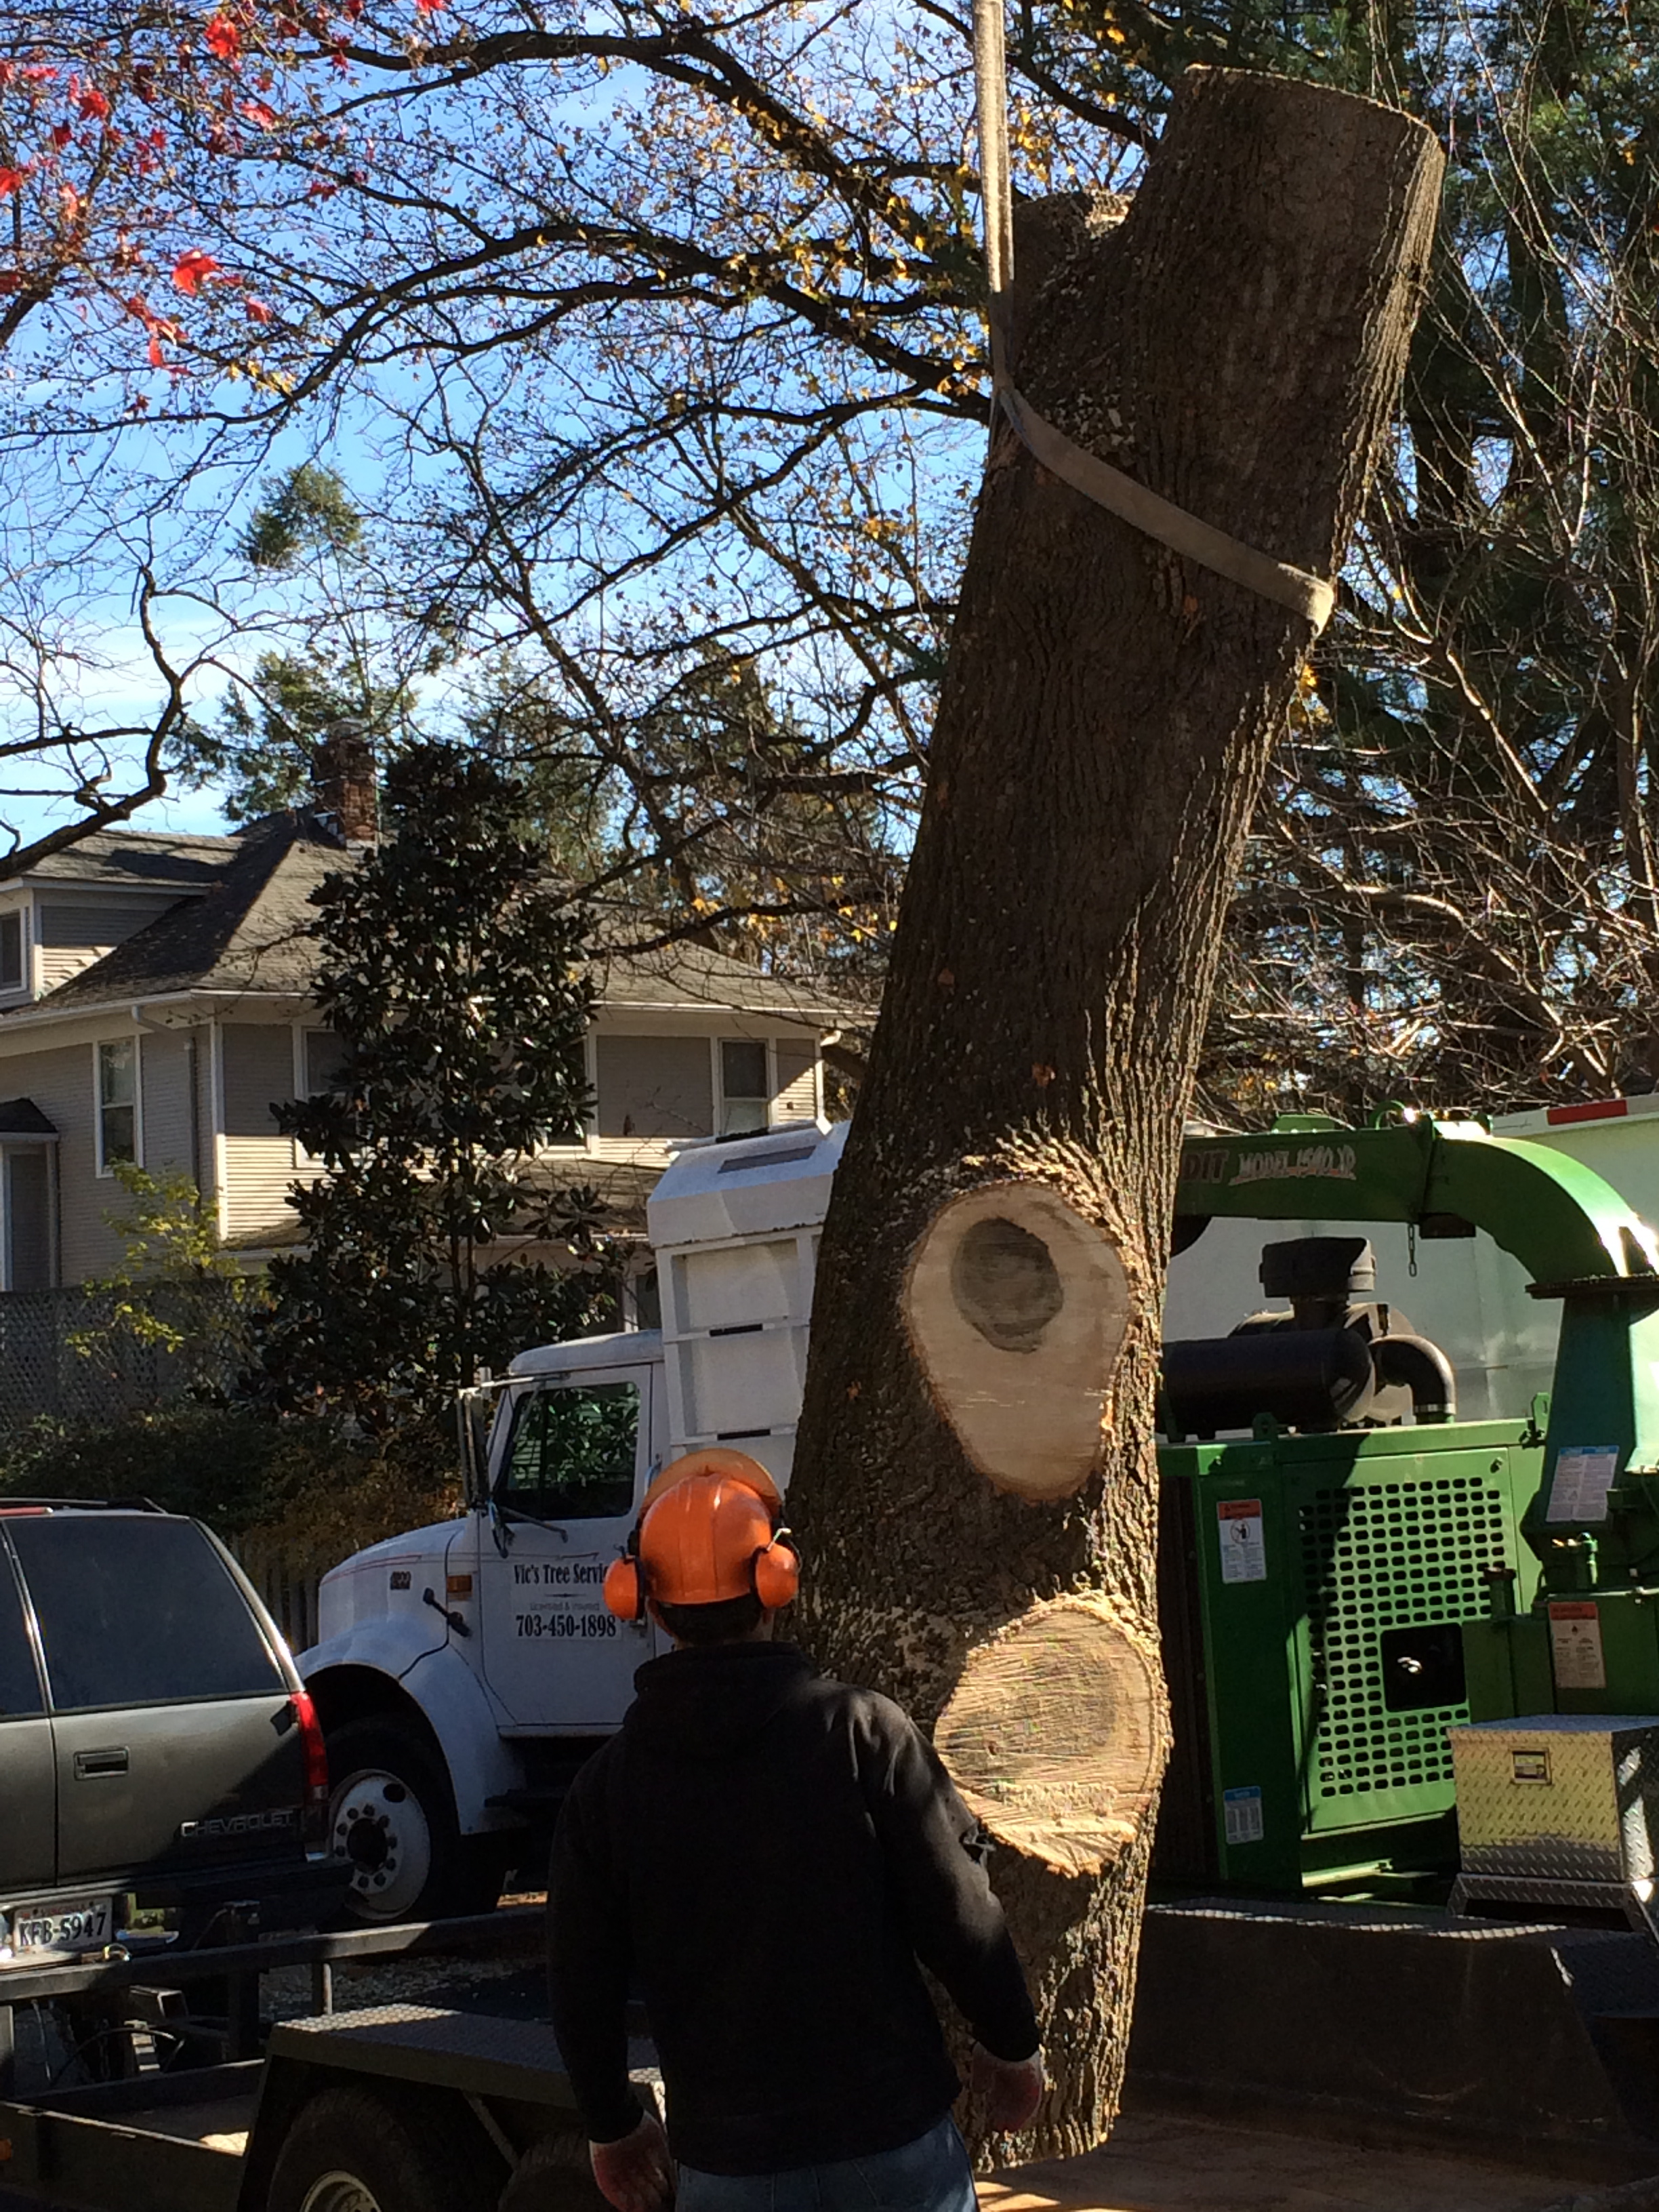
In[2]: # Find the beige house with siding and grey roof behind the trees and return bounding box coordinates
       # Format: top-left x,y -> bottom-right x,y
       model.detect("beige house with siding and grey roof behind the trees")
0,810 -> 836,1290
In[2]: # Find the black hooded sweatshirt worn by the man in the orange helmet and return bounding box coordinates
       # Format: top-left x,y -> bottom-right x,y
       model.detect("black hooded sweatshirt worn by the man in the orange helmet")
548,1643 -> 1038,2175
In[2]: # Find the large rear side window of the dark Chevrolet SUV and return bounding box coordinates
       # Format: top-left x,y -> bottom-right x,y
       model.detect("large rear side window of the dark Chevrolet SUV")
11,1513 -> 285,1712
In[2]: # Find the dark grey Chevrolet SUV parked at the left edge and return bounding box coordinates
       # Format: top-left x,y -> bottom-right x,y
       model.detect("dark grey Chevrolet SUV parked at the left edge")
0,1500 -> 338,1955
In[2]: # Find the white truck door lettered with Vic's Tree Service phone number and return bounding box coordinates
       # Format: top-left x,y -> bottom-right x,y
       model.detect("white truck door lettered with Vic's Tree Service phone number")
478,1367 -> 653,1734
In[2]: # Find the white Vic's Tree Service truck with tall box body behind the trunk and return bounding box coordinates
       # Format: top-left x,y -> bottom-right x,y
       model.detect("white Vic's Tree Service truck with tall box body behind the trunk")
299,1097 -> 1659,1922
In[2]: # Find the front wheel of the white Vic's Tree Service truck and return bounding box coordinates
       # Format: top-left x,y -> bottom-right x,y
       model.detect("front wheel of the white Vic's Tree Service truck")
327,1715 -> 506,1925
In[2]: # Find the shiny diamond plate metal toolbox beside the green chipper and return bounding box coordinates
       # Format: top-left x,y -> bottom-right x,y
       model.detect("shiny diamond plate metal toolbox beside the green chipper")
1447,1712 -> 1659,1883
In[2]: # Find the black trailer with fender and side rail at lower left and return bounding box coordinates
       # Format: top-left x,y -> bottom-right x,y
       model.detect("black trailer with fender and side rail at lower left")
0,1907 -> 637,2212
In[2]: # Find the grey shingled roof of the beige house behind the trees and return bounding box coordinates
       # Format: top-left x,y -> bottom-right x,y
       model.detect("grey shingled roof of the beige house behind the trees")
0,812 -> 872,1033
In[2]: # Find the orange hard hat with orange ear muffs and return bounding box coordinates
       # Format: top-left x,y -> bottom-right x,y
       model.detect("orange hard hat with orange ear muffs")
604,1447 -> 798,1617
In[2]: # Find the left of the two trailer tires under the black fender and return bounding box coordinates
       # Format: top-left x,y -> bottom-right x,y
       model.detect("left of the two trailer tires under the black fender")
266,2088 -> 500,2212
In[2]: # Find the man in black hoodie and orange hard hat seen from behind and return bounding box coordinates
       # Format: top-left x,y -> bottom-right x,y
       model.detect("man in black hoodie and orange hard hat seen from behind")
548,1451 -> 1042,2212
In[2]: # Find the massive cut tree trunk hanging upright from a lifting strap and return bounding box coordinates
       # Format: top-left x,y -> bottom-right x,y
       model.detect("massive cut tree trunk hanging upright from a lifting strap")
790,70 -> 1440,2156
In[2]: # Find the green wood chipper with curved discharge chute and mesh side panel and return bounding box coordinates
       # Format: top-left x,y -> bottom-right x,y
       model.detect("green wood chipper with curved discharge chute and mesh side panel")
1155,1117 -> 1659,1891
